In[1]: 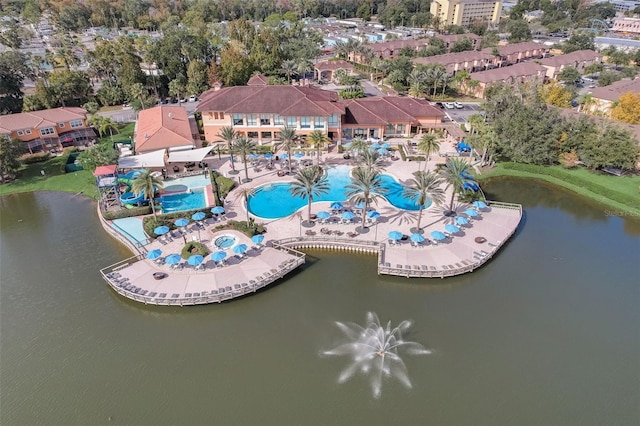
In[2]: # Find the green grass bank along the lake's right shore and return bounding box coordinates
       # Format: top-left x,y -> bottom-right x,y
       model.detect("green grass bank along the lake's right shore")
477,163 -> 640,217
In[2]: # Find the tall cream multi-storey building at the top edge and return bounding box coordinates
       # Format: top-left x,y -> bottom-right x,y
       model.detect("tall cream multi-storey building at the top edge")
431,0 -> 502,27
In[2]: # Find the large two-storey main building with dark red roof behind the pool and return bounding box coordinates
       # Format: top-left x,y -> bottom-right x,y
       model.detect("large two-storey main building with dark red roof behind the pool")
198,86 -> 444,144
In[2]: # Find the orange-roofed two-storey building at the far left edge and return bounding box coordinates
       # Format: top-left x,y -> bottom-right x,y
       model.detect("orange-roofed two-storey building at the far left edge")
0,107 -> 96,154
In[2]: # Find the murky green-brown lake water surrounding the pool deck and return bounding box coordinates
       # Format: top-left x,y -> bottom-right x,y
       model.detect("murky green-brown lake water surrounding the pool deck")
0,180 -> 640,425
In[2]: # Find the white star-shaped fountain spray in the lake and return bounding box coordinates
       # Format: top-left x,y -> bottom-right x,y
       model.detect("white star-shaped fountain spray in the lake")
324,312 -> 431,398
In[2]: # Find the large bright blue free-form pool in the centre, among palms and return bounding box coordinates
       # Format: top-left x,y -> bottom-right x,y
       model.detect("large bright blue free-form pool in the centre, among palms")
247,166 -> 431,219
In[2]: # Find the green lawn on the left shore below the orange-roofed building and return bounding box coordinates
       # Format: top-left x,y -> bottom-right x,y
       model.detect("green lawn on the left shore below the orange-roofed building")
0,154 -> 98,200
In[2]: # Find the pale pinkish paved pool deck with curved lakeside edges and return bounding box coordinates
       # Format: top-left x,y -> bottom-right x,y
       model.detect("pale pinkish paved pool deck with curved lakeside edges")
101,140 -> 522,306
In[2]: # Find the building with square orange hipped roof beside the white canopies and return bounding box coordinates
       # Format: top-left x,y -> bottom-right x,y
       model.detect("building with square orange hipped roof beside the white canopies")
133,105 -> 200,154
